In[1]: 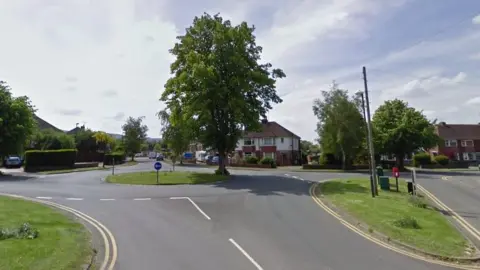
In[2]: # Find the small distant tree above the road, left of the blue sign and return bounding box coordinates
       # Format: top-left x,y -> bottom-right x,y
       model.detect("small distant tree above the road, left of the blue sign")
122,116 -> 148,161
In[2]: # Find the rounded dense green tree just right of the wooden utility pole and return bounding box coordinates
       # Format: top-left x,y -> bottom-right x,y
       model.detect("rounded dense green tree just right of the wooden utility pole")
372,99 -> 439,168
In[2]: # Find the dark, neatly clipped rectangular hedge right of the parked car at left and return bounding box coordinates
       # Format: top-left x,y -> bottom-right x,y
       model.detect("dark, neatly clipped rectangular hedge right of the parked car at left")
25,149 -> 77,171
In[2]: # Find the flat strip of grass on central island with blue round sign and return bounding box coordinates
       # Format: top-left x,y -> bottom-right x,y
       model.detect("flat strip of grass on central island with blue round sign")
106,171 -> 228,185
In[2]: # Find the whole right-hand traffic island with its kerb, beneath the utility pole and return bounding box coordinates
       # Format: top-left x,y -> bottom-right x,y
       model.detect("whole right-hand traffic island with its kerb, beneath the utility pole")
313,178 -> 480,263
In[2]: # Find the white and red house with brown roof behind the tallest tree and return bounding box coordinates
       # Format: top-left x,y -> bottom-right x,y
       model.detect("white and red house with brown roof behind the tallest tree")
235,119 -> 301,166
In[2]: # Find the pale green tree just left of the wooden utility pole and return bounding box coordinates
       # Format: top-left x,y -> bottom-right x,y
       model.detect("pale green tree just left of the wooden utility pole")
313,83 -> 366,169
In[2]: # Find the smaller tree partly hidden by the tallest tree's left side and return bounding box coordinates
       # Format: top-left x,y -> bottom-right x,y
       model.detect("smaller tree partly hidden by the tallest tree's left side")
157,110 -> 192,170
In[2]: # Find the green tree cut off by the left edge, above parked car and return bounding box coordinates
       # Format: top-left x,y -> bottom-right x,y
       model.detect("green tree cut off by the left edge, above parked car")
0,81 -> 36,160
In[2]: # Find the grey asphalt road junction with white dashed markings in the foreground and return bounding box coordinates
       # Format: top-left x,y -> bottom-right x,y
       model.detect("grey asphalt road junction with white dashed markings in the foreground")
0,163 -> 458,270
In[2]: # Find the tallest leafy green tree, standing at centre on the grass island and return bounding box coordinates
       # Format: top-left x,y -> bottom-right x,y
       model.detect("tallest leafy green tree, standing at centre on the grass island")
161,13 -> 285,174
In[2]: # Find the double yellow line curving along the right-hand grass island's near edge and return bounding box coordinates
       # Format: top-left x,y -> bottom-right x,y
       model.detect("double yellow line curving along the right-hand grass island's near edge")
309,183 -> 480,270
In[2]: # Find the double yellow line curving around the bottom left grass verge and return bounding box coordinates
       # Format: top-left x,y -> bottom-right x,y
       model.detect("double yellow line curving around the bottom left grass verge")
0,193 -> 118,270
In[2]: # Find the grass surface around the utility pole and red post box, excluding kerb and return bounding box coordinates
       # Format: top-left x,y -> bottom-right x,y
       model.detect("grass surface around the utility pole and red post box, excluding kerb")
316,178 -> 468,256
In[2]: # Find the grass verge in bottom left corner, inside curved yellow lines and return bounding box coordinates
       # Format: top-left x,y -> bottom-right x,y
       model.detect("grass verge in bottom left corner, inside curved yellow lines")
0,196 -> 92,270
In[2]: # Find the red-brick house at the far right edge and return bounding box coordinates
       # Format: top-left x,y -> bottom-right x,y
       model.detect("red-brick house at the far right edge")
430,122 -> 480,161
